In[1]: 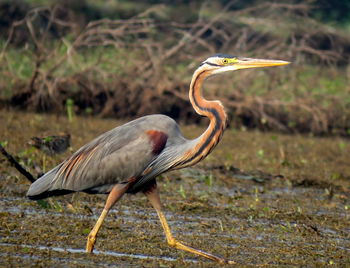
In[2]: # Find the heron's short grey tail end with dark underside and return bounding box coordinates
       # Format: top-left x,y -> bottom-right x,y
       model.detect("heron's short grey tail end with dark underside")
27,166 -> 72,200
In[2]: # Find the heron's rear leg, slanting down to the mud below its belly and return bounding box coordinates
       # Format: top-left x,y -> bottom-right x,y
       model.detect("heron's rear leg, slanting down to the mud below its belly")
86,184 -> 128,253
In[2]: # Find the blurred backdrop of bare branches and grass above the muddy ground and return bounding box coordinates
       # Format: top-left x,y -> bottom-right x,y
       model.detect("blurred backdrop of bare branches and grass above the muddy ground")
0,0 -> 350,136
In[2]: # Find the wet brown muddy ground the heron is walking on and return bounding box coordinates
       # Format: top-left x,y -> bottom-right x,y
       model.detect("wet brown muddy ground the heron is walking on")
0,111 -> 350,267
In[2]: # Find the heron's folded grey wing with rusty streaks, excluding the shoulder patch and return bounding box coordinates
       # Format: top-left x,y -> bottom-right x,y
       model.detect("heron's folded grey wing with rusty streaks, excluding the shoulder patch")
33,123 -> 159,193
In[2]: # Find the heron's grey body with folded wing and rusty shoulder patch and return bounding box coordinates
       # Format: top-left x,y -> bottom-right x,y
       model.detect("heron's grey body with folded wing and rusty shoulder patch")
27,115 -> 187,198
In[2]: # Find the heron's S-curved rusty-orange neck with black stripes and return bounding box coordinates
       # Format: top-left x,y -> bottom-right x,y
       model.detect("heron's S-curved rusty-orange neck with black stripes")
181,68 -> 227,167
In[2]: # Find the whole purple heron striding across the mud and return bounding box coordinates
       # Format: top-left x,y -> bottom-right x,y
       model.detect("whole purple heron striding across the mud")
27,54 -> 289,263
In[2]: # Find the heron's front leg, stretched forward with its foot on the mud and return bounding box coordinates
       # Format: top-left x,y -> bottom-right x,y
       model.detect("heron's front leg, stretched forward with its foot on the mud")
144,184 -> 234,264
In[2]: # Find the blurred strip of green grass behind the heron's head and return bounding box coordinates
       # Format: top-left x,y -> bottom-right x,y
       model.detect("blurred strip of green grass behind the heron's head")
0,42 -> 350,103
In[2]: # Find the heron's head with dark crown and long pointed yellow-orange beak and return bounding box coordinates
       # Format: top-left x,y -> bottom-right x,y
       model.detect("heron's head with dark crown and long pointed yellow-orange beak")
201,54 -> 290,74
